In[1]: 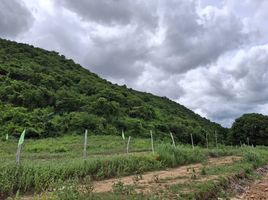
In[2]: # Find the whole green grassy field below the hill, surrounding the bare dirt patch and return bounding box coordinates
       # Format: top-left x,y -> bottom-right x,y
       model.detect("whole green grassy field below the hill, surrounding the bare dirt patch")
0,135 -> 268,199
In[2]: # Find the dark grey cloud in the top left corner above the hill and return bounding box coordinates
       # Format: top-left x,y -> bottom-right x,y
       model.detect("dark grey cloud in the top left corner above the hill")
0,0 -> 33,37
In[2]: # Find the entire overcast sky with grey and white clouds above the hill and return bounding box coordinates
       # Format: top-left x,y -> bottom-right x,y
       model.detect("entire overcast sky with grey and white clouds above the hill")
0,0 -> 268,126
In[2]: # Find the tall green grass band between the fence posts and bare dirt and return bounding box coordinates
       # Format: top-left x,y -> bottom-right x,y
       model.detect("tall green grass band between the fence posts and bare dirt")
0,154 -> 162,196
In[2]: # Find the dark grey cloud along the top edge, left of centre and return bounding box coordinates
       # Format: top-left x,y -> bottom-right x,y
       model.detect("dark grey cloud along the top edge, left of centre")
58,0 -> 157,26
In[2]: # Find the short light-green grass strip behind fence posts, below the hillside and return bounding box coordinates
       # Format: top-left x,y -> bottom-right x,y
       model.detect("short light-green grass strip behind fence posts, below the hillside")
0,135 -> 158,159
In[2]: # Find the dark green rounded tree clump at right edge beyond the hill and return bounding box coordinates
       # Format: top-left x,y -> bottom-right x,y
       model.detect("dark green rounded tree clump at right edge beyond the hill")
229,113 -> 268,145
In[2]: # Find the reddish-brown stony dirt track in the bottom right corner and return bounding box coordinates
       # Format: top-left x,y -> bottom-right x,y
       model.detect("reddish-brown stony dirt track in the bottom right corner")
231,173 -> 268,200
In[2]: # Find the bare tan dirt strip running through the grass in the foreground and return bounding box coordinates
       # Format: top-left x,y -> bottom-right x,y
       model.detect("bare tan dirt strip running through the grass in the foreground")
94,156 -> 240,193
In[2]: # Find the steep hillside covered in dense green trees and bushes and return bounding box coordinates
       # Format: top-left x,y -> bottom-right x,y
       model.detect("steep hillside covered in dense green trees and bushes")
0,39 -> 226,143
